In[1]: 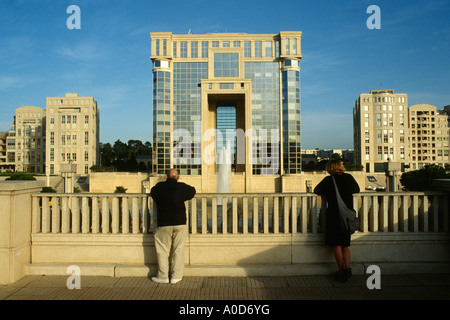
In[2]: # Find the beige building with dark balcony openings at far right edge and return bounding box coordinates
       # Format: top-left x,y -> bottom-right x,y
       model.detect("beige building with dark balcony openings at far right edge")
409,104 -> 449,170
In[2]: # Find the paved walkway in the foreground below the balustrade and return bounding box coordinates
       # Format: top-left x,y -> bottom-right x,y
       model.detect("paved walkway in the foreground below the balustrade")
0,273 -> 450,302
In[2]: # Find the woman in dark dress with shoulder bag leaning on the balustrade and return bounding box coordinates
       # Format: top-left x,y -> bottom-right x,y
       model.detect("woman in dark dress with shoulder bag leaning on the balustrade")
314,160 -> 359,282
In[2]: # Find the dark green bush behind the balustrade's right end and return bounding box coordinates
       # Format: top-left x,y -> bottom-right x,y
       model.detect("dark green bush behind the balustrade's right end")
400,164 -> 450,191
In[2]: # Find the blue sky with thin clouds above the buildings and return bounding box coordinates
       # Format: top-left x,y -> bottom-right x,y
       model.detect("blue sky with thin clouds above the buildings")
0,0 -> 450,149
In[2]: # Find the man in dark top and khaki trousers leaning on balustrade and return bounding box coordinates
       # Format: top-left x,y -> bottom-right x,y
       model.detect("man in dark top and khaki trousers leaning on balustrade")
150,169 -> 196,284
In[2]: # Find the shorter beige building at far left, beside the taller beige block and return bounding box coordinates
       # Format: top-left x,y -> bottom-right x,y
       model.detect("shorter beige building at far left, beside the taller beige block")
5,106 -> 45,174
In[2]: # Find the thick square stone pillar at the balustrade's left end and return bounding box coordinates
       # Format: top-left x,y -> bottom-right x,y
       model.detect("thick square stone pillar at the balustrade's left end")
0,181 -> 45,285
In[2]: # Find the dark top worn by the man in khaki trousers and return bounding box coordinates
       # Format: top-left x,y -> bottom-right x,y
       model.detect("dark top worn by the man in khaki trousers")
150,178 -> 196,227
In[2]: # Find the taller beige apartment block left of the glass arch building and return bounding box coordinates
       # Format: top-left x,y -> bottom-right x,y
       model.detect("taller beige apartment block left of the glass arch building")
46,93 -> 100,175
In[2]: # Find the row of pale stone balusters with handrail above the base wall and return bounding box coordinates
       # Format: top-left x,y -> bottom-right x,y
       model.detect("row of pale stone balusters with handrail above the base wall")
32,192 -> 449,235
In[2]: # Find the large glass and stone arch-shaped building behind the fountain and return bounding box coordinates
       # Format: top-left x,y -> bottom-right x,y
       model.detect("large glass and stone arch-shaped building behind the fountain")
150,31 -> 302,192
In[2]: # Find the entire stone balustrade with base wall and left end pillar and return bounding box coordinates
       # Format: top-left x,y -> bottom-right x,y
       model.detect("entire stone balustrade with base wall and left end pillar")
0,180 -> 450,284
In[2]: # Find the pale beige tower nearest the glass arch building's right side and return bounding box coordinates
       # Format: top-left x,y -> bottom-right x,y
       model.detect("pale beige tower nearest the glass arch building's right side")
353,90 -> 409,173
